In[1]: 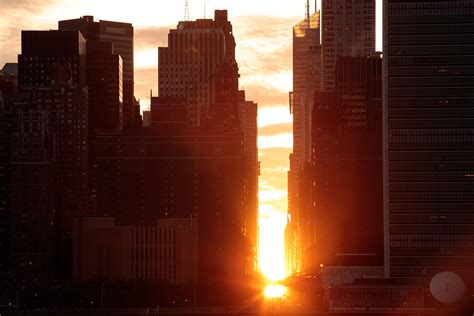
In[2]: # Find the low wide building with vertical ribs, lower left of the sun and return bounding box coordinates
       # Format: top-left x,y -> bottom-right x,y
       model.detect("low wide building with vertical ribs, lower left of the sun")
73,217 -> 198,284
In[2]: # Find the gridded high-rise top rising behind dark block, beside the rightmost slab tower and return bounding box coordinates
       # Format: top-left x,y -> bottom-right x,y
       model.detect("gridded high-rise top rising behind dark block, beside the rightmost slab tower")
321,0 -> 375,91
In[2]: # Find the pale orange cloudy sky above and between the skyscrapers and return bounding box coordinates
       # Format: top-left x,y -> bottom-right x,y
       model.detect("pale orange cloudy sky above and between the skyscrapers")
0,0 -> 381,237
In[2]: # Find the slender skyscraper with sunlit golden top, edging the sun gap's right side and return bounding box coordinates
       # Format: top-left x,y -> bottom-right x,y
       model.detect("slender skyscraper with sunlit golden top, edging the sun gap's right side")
288,8 -> 321,271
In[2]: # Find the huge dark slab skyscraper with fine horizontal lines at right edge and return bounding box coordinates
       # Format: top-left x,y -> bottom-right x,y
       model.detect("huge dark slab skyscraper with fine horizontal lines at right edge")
384,0 -> 474,292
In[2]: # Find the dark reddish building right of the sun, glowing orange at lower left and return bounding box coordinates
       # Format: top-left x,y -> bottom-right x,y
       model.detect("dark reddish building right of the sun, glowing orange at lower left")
310,56 -> 383,271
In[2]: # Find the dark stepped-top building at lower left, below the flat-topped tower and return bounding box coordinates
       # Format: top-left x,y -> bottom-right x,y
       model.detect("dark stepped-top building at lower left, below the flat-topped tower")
9,107 -> 56,292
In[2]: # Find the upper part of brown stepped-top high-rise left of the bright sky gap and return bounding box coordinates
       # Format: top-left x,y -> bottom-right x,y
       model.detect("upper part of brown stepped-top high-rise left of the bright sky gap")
158,10 -> 238,125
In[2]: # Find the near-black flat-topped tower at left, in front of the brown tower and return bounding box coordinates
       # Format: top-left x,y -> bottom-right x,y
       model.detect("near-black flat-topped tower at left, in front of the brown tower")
18,31 -> 90,278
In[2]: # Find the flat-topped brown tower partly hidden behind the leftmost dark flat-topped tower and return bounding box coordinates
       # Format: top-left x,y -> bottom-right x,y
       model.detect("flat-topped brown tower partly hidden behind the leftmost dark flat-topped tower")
58,16 -> 135,130
